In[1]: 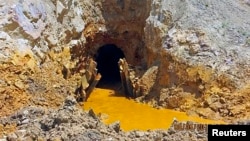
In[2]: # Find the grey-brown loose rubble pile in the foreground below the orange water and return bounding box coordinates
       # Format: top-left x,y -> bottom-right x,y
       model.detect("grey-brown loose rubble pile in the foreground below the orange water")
0,97 -> 206,141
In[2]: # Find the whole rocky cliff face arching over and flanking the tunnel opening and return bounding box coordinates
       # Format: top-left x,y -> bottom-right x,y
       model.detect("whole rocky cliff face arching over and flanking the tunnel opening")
0,0 -> 250,137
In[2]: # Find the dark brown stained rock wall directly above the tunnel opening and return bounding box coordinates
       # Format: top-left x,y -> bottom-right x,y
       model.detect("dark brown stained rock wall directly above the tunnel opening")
83,0 -> 150,66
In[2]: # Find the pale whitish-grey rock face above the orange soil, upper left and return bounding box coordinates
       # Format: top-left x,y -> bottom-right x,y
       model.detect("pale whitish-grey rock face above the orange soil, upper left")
0,0 -> 101,61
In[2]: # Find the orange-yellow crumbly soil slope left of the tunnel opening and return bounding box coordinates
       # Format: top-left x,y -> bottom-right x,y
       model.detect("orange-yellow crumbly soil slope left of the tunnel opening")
0,49 -> 81,135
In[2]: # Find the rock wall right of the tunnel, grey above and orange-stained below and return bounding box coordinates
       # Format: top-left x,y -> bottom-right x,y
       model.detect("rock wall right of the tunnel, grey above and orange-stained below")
142,0 -> 250,118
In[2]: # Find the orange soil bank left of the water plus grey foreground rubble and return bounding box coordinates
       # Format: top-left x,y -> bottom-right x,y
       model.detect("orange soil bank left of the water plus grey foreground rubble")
0,52 -> 248,140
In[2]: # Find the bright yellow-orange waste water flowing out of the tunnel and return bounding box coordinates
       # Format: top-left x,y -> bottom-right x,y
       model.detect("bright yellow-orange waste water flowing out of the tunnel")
84,88 -> 225,131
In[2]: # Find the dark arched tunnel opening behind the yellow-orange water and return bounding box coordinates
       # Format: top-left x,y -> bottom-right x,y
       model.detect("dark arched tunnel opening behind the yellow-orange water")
96,44 -> 125,87
